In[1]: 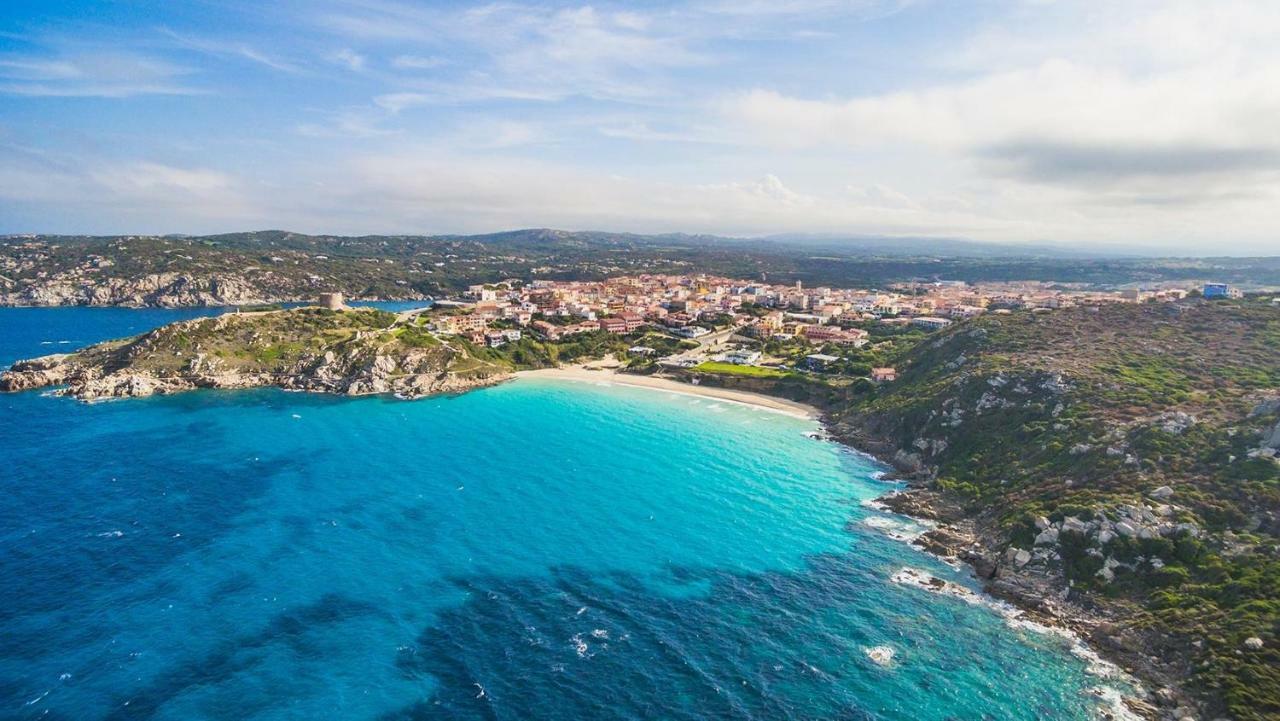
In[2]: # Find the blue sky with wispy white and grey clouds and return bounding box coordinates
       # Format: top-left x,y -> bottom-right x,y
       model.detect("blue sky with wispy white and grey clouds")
0,0 -> 1280,255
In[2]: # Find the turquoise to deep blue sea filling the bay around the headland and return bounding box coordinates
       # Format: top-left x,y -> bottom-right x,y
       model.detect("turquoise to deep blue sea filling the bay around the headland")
0,309 -> 1131,721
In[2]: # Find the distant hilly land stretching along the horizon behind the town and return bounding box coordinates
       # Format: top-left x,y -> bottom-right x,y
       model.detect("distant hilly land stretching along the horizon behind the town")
0,228 -> 1280,305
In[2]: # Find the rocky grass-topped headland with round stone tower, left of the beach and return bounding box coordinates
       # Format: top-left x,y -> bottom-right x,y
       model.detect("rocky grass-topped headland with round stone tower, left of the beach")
0,307 -> 509,401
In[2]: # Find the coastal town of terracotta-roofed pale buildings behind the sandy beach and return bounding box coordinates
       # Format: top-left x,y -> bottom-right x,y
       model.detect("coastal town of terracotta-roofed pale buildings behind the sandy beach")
399,274 -> 1239,383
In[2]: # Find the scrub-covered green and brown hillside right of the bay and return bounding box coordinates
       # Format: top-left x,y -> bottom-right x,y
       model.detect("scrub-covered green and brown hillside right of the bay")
841,297 -> 1280,720
